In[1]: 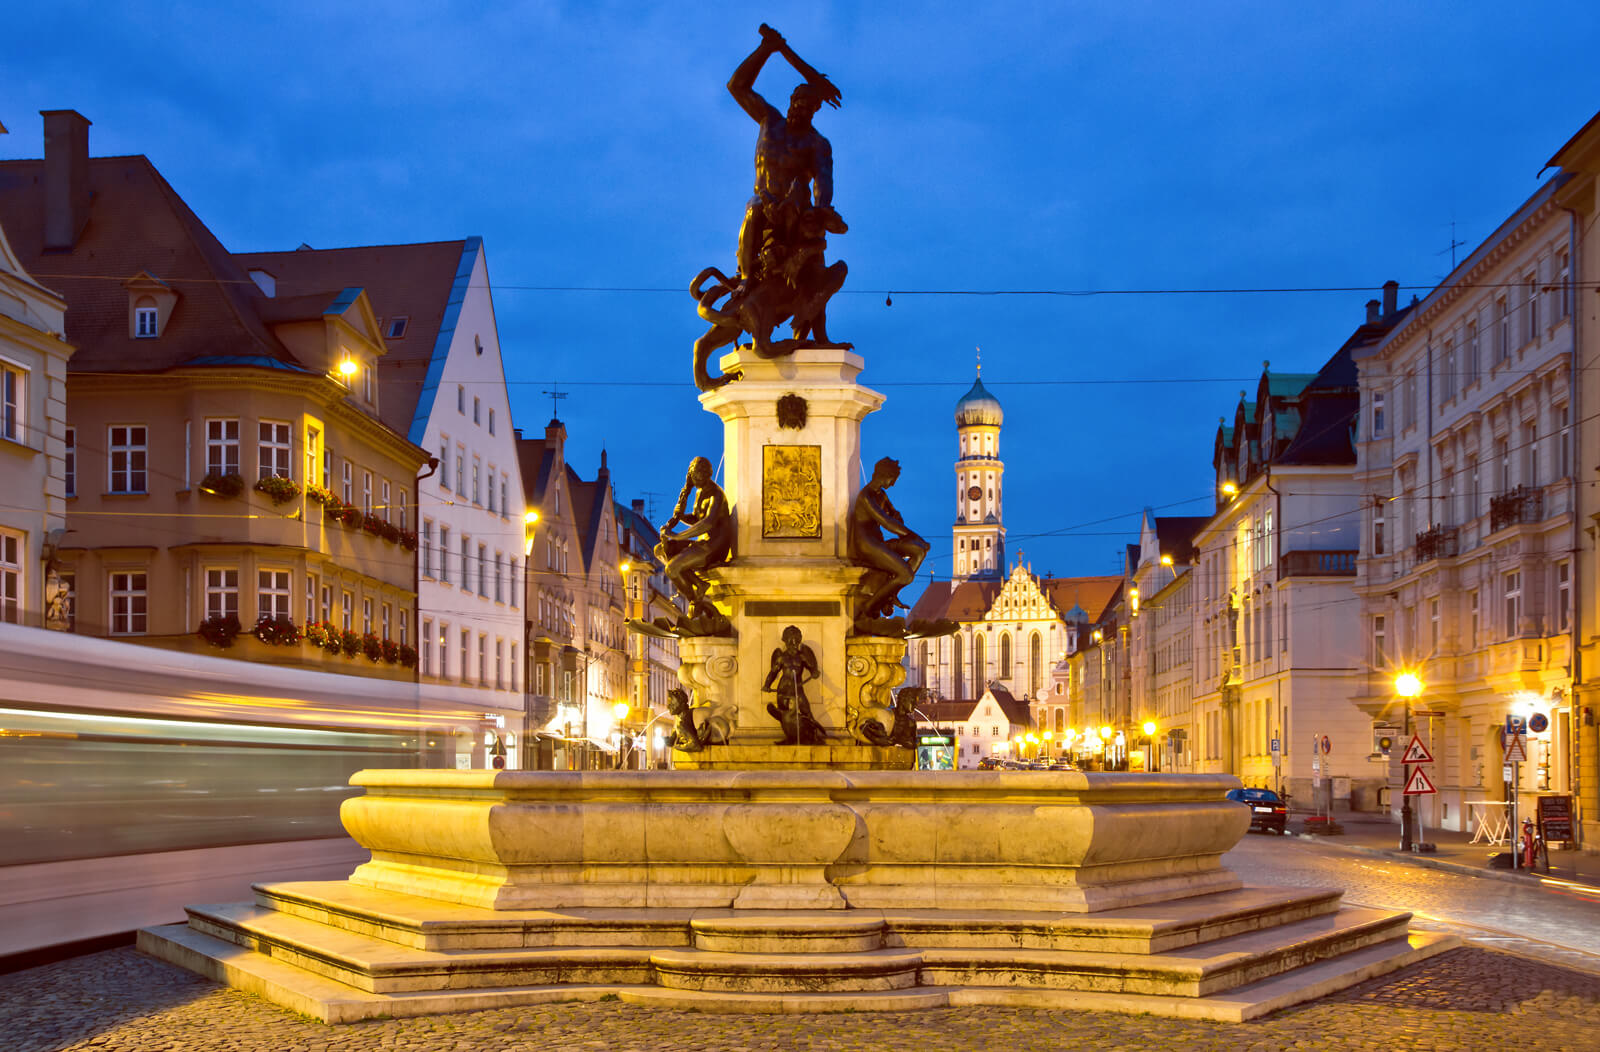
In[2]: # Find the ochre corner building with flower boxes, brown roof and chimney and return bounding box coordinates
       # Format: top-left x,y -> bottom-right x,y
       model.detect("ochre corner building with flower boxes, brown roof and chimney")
0,110 -> 427,679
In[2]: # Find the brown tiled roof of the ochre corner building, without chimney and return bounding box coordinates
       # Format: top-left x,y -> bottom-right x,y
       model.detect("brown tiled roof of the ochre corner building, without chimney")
0,155 -> 297,373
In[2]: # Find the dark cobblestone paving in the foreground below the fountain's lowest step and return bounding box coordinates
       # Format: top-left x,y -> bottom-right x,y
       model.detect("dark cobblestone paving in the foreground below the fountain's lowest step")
0,948 -> 1600,1052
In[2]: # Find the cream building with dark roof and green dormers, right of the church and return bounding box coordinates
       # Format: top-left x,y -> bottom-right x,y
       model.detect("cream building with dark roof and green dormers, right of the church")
1190,305 -> 1410,807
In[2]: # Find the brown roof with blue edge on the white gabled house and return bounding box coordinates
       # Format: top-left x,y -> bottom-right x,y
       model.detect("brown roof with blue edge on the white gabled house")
234,237 -> 483,443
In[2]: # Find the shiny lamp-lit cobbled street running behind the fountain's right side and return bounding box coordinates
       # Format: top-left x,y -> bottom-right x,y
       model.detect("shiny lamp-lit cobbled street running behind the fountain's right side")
1222,835 -> 1600,965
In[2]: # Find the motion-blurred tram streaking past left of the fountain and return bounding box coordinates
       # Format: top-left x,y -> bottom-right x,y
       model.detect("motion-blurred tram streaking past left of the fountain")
0,625 -> 512,961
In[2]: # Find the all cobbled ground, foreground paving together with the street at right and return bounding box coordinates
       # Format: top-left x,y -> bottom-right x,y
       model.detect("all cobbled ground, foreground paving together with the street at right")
0,835 -> 1600,1052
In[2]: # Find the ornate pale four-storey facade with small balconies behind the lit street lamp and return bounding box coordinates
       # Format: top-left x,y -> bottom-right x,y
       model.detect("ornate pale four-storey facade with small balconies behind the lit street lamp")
1355,173 -> 1594,830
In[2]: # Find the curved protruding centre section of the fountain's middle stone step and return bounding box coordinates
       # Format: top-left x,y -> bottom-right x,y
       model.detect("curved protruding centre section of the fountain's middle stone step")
650,950 -> 923,993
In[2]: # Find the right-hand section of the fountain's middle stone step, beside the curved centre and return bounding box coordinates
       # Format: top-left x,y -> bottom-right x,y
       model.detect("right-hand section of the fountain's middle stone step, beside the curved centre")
920,907 -> 1411,998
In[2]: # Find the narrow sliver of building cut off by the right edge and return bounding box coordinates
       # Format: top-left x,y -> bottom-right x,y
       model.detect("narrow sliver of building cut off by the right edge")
1549,114 -> 1600,846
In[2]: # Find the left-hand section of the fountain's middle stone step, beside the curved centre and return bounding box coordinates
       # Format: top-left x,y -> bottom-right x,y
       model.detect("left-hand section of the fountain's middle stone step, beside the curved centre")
189,903 -> 653,993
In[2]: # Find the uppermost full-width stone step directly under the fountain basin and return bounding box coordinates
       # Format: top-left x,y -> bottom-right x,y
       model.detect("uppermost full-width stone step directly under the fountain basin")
256,881 -> 1339,953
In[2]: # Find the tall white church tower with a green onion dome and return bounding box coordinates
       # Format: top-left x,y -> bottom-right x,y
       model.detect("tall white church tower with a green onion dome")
950,365 -> 1005,580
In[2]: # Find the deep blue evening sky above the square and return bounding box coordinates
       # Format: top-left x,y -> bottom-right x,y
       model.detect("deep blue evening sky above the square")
0,0 -> 1600,592
